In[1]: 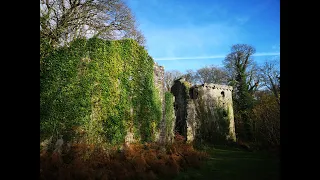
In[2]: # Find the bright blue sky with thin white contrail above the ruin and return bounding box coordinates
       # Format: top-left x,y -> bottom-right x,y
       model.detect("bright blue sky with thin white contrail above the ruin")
127,0 -> 280,72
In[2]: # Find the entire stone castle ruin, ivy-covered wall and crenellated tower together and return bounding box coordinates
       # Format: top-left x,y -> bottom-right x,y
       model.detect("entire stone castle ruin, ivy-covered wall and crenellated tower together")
40,38 -> 235,148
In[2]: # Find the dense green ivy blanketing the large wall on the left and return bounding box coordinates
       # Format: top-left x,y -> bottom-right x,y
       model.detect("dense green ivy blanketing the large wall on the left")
40,38 -> 162,144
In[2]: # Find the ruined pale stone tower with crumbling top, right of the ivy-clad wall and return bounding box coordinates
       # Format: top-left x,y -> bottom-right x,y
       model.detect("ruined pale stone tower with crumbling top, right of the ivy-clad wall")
171,78 -> 236,142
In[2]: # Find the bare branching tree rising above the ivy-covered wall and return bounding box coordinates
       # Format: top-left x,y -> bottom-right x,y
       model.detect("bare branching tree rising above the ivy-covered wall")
40,0 -> 145,46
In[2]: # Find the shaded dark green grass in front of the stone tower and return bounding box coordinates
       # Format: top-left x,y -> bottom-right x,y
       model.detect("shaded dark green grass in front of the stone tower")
174,146 -> 280,180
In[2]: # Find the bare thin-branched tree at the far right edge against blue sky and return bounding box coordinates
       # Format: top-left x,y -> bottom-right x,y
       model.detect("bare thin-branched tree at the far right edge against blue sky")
260,60 -> 280,105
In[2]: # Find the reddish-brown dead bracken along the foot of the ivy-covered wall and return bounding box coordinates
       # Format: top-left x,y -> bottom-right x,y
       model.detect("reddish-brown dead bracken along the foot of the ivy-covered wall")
40,135 -> 208,180
